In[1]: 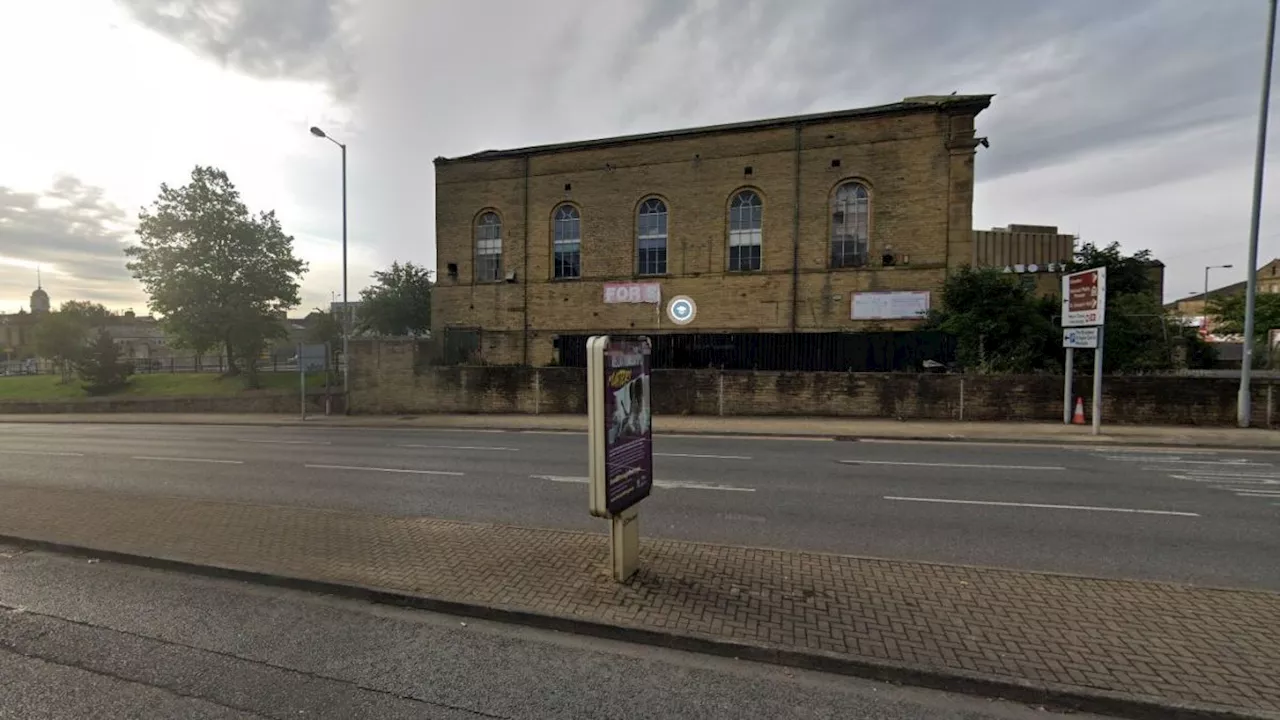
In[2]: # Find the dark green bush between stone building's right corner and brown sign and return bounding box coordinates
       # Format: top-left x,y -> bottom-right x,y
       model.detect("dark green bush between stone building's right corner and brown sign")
925,268 -> 1061,373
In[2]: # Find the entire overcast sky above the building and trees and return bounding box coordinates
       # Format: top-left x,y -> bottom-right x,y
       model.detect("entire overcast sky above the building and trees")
0,0 -> 1280,311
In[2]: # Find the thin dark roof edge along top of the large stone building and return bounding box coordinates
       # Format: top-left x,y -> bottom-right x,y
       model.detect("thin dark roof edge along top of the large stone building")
435,95 -> 995,165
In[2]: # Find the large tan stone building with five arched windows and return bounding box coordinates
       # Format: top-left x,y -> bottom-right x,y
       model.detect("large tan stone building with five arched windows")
433,95 -> 992,365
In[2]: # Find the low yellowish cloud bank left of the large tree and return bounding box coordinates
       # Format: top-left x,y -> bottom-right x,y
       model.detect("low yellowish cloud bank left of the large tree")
0,176 -> 145,313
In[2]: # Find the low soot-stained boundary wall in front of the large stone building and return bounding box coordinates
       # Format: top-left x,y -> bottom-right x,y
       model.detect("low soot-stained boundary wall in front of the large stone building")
351,341 -> 1280,425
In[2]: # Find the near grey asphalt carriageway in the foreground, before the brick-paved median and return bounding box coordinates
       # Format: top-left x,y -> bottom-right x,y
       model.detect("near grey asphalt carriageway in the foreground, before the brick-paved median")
0,546 -> 1111,720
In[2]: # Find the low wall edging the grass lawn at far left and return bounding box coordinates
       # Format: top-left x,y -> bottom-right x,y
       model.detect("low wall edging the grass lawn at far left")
0,391 -> 342,415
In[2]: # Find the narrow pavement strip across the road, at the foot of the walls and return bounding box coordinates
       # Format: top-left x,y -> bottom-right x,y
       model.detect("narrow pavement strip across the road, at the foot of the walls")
0,413 -> 1280,450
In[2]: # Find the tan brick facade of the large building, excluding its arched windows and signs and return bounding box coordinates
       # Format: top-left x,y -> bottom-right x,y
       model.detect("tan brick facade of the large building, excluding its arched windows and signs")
433,98 -> 974,365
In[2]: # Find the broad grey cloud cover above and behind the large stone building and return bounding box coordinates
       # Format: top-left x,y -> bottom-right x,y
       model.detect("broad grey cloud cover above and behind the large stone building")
99,0 -> 1276,303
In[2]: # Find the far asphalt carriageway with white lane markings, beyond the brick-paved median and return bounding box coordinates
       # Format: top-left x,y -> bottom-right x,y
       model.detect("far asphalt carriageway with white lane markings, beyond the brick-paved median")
0,424 -> 1280,589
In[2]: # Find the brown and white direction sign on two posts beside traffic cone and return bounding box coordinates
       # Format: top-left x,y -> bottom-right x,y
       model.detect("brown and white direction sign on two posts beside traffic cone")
1062,268 -> 1107,434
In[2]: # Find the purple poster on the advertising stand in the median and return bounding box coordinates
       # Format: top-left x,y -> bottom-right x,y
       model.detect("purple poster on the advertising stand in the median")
604,338 -> 653,515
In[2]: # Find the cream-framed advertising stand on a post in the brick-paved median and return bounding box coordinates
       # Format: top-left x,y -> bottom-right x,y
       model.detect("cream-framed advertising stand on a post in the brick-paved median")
586,336 -> 653,583
